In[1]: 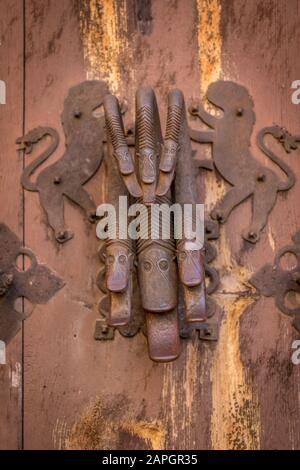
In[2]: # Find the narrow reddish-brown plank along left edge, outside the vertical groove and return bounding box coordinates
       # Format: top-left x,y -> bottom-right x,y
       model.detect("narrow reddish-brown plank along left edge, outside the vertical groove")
0,0 -> 23,449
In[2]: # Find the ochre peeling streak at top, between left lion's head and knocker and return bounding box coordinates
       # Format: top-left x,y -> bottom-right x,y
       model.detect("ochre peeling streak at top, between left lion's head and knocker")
80,0 -> 131,92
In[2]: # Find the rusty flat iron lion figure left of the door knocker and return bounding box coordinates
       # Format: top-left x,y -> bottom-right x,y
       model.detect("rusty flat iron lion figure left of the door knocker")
17,80 -> 108,243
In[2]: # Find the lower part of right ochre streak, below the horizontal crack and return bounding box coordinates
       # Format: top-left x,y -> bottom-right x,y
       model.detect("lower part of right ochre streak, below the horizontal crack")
211,296 -> 260,450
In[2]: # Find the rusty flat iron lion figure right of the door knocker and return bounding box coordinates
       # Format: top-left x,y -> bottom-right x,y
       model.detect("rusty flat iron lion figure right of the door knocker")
189,80 -> 299,243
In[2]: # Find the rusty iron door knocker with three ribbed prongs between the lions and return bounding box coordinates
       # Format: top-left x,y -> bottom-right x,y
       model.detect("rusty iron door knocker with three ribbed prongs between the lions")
96,88 -> 206,361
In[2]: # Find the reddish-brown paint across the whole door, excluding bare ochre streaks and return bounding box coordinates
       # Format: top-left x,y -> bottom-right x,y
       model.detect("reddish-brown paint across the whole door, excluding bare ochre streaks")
0,0 -> 300,449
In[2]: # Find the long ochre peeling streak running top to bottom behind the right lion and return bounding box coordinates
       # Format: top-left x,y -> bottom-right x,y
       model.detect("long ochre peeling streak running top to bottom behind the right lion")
197,0 -> 260,449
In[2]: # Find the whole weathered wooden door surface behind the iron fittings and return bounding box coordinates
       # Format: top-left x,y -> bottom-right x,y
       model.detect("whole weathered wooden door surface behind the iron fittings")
0,0 -> 300,449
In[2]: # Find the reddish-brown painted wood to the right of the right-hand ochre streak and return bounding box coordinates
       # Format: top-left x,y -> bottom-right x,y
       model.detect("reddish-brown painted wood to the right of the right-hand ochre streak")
220,0 -> 300,449
